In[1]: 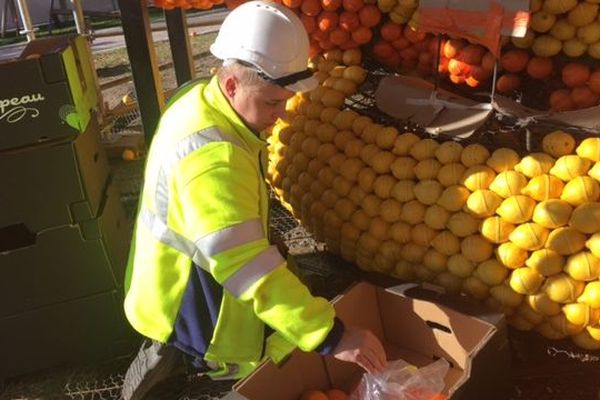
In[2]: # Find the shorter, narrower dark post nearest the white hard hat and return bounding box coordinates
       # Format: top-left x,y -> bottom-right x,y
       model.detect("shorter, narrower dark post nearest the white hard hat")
165,8 -> 194,86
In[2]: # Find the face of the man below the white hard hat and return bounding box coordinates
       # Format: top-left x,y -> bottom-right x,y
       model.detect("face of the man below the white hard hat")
231,79 -> 294,132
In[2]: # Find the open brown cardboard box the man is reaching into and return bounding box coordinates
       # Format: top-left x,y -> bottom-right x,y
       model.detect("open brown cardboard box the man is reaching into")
226,282 -> 509,400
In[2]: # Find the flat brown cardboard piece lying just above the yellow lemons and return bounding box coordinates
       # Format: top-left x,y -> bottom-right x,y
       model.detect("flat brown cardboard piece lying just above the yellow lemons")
375,75 -> 492,138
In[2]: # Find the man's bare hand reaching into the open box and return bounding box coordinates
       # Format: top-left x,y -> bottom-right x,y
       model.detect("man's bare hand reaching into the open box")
331,325 -> 387,373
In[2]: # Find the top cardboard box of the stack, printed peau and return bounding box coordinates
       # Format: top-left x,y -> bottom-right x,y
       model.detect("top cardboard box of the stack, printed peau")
0,36 -> 98,149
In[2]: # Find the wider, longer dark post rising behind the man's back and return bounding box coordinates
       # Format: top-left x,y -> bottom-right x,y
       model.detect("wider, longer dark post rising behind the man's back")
119,0 -> 165,145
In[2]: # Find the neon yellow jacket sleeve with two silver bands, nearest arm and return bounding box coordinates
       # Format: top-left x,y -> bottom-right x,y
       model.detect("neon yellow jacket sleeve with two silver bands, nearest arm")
169,143 -> 335,351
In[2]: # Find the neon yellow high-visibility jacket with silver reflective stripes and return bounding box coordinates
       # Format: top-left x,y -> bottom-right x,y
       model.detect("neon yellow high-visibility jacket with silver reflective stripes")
125,78 -> 334,375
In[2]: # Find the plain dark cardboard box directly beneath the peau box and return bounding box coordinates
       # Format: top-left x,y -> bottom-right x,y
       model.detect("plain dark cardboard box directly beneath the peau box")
0,114 -> 109,233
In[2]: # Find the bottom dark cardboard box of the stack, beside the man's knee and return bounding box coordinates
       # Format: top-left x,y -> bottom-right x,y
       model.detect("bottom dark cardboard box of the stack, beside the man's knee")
0,290 -> 139,378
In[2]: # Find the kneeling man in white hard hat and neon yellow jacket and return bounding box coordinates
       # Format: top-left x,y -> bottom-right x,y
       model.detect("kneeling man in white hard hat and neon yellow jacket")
123,1 -> 386,400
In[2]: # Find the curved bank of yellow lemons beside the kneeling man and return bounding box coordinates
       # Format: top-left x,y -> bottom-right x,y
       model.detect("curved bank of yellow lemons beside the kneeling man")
268,50 -> 600,349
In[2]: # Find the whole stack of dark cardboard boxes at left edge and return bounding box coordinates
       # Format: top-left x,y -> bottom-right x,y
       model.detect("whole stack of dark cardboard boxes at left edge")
0,37 -> 134,377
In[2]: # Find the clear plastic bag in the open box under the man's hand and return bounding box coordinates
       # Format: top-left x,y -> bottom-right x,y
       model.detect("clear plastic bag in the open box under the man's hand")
350,358 -> 450,400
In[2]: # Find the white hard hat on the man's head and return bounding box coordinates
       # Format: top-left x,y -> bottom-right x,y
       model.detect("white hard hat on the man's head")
210,1 -> 318,92
